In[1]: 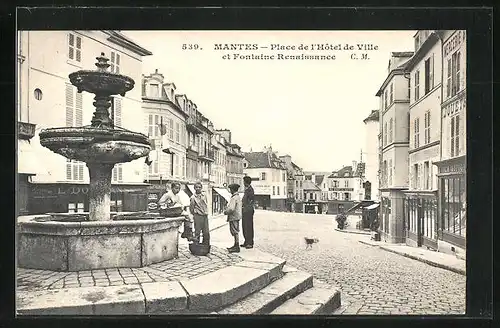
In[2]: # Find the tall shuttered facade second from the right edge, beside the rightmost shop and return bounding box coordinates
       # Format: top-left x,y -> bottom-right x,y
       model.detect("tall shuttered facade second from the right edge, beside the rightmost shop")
405,30 -> 443,249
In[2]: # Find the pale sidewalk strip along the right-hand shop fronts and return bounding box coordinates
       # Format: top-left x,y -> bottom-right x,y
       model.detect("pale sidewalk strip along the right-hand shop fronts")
359,240 -> 466,276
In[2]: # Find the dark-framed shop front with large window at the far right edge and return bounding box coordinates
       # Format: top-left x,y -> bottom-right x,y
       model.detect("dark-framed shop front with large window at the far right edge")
436,155 -> 467,252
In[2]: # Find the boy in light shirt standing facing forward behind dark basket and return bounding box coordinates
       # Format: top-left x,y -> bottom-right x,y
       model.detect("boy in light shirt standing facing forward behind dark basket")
189,182 -> 210,245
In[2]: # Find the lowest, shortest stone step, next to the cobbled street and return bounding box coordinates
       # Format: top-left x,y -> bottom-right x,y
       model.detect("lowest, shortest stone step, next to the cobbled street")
270,279 -> 340,315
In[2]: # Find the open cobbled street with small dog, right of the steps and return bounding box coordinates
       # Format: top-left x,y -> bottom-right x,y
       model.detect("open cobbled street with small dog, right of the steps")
212,211 -> 466,315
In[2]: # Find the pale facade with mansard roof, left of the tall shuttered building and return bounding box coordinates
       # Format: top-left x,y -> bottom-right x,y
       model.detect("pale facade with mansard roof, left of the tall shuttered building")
376,52 -> 413,243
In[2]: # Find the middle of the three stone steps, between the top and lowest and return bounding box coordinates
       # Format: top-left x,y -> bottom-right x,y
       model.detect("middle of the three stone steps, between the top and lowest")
218,266 -> 313,314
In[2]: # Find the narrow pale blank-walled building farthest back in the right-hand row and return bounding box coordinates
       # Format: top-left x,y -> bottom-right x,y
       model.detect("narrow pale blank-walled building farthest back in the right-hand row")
363,110 -> 380,200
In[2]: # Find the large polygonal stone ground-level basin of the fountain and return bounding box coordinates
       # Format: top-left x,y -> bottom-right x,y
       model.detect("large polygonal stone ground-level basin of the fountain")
17,213 -> 184,271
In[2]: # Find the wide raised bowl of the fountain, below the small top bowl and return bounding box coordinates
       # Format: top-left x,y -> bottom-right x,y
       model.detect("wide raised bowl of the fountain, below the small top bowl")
40,127 -> 151,164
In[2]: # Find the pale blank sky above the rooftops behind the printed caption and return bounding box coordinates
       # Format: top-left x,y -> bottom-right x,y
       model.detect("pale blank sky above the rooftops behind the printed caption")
122,30 -> 415,172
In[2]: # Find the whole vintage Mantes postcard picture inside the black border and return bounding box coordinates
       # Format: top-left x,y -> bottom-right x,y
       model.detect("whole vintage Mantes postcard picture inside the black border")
16,30 -> 467,316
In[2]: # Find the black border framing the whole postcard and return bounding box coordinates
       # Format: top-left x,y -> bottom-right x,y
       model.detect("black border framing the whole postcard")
0,4 -> 493,327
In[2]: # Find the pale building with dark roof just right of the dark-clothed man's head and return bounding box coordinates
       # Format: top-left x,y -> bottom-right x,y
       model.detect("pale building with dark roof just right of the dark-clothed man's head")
243,147 -> 287,211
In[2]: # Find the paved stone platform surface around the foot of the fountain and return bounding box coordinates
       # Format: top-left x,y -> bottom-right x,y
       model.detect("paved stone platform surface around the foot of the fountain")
17,245 -> 243,290
